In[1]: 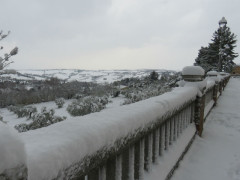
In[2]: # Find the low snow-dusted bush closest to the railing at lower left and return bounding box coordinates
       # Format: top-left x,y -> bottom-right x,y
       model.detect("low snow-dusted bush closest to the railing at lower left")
15,107 -> 66,132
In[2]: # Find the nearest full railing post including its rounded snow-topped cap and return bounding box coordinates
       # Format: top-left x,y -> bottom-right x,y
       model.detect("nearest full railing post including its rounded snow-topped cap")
182,66 -> 206,136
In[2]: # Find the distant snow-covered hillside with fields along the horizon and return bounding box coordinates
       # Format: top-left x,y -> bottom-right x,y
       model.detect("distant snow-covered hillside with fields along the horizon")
0,69 -> 174,83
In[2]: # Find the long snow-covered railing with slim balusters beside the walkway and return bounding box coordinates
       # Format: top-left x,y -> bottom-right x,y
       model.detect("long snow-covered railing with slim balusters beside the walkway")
0,66 -> 229,180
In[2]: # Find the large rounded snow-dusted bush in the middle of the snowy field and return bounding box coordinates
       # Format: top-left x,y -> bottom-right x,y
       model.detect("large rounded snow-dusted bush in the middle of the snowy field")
67,96 -> 108,116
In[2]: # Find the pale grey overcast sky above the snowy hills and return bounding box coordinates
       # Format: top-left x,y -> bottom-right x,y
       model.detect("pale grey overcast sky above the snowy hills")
0,0 -> 240,70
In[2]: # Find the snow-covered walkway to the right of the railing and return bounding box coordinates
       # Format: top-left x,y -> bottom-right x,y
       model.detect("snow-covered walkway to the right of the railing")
171,78 -> 240,180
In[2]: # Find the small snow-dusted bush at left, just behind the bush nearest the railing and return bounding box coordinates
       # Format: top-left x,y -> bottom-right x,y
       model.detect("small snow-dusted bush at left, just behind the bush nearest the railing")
8,106 -> 37,118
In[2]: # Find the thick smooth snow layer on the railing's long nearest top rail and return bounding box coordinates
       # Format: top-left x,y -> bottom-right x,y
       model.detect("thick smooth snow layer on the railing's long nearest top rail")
20,87 -> 197,180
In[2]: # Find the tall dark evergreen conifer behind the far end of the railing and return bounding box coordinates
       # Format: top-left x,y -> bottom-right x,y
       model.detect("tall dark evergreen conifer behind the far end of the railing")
195,18 -> 238,72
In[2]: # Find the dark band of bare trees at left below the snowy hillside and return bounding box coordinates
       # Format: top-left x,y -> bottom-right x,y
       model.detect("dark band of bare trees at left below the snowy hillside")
0,78 -> 112,108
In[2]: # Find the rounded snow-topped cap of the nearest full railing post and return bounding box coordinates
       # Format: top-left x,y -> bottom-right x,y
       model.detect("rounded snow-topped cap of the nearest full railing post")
182,66 -> 205,82
